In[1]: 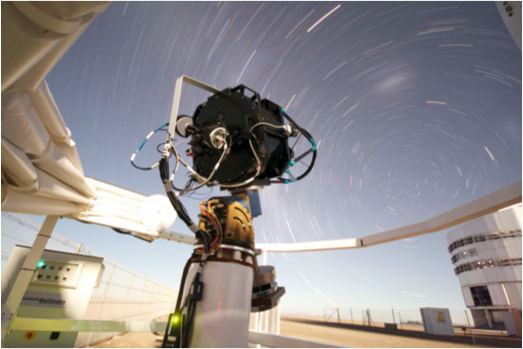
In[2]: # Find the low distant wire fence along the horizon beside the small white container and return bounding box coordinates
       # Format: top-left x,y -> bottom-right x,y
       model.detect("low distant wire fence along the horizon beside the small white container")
323,308 -> 474,331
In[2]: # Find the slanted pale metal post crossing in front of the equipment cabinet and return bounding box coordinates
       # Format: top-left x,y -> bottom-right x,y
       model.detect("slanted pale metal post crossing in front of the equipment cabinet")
2,216 -> 60,337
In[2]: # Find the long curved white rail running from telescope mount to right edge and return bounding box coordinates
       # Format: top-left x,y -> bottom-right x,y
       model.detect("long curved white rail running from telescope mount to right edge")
256,181 -> 521,252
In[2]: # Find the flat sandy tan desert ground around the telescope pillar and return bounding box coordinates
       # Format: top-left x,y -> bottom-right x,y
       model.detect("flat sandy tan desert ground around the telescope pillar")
81,315 -> 522,349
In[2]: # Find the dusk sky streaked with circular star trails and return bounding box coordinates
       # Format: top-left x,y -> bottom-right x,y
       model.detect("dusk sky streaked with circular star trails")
22,1 -> 522,316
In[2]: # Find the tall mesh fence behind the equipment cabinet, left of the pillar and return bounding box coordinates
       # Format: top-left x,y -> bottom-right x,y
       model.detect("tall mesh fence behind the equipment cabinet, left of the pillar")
1,212 -> 177,348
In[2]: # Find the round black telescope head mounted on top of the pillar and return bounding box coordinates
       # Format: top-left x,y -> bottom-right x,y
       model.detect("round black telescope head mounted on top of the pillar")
186,85 -> 293,185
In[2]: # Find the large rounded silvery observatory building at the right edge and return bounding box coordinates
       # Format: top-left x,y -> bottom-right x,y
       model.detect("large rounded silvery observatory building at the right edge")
447,204 -> 521,328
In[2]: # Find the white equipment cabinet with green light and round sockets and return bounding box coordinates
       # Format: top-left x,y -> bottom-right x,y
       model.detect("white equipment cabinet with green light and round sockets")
2,245 -> 105,349
